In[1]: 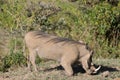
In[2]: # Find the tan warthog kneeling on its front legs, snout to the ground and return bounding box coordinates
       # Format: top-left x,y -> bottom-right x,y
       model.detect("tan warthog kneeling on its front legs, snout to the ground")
25,31 -> 100,76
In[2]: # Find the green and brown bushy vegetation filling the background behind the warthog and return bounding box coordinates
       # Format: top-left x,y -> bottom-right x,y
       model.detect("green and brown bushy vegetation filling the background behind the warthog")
0,0 -> 120,71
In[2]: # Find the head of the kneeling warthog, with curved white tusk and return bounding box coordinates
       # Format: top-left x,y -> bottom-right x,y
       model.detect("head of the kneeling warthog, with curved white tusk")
79,40 -> 101,74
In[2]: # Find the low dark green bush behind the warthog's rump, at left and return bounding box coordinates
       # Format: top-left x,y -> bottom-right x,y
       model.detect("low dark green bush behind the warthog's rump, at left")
1,52 -> 26,72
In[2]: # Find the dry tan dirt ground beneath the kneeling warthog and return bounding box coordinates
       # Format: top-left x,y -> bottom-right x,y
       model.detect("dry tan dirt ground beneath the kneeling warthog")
0,59 -> 120,80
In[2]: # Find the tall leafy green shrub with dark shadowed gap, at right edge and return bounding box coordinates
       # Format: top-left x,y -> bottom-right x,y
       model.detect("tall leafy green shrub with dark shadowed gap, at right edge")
86,2 -> 120,58
